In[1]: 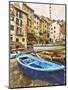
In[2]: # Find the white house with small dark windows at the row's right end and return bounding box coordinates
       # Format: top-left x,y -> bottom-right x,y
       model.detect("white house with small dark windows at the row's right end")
49,21 -> 60,43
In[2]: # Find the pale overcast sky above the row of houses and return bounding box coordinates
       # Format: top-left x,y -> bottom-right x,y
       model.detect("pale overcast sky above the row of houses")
27,3 -> 65,20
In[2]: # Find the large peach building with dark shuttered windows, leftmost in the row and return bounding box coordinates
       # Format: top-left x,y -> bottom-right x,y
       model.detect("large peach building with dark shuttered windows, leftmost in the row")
10,2 -> 27,48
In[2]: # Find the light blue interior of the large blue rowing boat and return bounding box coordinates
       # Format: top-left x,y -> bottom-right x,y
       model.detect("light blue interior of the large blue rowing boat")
20,56 -> 65,69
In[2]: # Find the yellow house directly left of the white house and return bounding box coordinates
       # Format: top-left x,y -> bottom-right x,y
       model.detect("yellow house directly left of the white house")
40,16 -> 50,43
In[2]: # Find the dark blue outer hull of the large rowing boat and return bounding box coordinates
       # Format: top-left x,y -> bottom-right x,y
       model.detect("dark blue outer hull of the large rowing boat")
17,61 -> 66,85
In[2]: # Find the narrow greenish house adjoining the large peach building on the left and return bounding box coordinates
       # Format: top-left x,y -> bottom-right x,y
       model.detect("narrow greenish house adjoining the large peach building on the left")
22,3 -> 34,32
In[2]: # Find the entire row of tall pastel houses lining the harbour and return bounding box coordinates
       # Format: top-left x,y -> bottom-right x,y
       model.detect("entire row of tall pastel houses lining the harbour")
10,2 -> 65,48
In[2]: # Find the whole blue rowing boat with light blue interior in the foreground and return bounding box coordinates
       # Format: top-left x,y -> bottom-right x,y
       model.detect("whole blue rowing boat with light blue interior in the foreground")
16,53 -> 65,85
